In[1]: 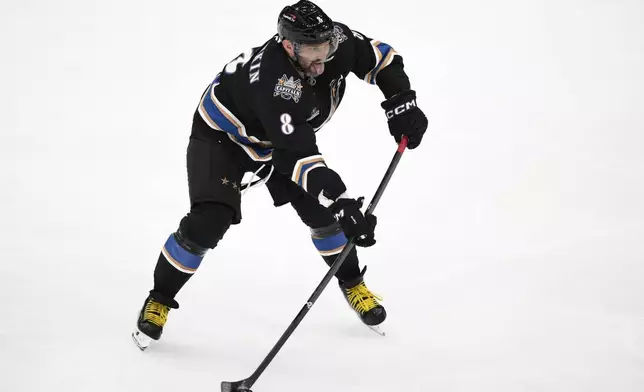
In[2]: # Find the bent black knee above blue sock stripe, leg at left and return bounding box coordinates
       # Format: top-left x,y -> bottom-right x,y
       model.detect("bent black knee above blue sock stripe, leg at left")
177,203 -> 234,251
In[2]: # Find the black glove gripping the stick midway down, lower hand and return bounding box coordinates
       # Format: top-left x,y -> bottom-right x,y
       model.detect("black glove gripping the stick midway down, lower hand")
329,197 -> 377,248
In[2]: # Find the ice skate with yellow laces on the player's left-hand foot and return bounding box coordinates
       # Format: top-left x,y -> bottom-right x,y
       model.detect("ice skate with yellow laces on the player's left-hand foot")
132,291 -> 179,351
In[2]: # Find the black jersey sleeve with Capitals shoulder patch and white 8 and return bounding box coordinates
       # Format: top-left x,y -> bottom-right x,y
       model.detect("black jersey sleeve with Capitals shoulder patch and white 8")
252,70 -> 346,207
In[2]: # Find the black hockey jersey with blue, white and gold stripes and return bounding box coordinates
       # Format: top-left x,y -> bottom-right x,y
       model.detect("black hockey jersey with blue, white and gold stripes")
198,23 -> 409,205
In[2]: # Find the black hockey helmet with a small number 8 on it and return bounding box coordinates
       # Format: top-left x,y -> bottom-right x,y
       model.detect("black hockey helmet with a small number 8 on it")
277,0 -> 336,44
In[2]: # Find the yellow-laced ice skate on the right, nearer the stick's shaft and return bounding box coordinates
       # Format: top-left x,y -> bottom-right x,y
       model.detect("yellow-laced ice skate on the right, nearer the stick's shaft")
340,267 -> 387,336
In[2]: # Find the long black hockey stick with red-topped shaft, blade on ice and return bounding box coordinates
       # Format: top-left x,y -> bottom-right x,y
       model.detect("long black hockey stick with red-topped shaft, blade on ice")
221,136 -> 408,392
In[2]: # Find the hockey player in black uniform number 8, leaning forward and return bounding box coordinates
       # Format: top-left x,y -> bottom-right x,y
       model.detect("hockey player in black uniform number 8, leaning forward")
133,1 -> 427,349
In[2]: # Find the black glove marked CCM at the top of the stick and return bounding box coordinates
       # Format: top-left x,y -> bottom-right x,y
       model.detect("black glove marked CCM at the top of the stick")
380,90 -> 427,150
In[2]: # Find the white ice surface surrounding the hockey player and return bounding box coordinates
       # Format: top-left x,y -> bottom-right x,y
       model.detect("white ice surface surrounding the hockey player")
0,0 -> 644,392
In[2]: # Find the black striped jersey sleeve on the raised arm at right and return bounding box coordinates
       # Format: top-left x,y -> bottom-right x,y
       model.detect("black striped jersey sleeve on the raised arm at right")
338,23 -> 410,98
